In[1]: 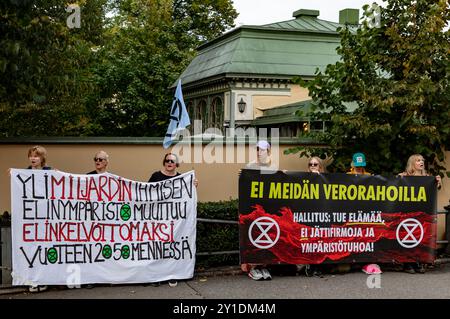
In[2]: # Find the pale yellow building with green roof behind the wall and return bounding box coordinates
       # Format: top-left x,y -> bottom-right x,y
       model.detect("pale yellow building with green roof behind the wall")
180,9 -> 359,136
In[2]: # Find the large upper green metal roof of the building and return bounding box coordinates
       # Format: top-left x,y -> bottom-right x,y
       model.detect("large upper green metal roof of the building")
180,10 -> 342,85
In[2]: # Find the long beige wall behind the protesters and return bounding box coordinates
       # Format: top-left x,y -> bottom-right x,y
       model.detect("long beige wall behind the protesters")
0,144 -> 450,238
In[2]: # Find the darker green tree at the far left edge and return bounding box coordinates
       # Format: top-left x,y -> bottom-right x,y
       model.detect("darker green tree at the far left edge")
0,0 -> 104,137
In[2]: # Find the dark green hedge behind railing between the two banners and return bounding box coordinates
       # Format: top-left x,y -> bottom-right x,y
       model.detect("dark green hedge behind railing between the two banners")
196,200 -> 239,267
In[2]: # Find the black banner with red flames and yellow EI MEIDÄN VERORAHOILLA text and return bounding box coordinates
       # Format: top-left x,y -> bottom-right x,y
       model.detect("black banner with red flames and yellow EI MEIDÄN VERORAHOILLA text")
239,170 -> 437,264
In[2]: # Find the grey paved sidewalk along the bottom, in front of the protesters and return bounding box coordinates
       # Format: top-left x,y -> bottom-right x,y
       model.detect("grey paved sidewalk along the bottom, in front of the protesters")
0,264 -> 450,302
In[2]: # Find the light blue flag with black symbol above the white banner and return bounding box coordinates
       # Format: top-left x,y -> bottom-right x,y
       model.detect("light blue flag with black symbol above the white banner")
163,80 -> 191,148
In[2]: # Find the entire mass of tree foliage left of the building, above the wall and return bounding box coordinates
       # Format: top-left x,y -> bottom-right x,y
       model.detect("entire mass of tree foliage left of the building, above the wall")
0,0 -> 236,137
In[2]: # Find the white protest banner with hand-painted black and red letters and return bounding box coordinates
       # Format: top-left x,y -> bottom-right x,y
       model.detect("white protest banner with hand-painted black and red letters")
11,169 -> 197,285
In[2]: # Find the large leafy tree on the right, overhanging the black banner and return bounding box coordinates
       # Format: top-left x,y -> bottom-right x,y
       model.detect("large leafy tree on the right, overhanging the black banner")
289,0 -> 450,175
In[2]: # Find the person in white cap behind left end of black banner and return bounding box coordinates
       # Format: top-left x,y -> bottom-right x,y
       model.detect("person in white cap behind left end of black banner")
241,140 -> 272,280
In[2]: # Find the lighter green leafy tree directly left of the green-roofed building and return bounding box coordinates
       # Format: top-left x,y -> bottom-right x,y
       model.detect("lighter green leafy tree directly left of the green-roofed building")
89,0 -> 236,136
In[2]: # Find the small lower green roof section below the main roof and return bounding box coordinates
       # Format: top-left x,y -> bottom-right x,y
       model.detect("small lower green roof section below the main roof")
251,100 -> 313,126
